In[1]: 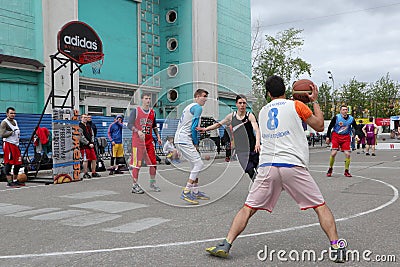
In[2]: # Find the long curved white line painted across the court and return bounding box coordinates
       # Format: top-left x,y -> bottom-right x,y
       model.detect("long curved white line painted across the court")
0,171 -> 399,259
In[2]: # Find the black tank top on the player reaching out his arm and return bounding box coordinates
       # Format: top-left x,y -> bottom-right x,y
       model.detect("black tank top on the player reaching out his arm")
231,111 -> 256,152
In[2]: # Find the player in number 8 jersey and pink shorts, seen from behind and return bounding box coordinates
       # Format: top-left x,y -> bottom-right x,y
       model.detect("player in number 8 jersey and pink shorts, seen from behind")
206,75 -> 346,262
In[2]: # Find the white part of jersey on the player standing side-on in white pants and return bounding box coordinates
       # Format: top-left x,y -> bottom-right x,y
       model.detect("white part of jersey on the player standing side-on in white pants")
174,103 -> 200,144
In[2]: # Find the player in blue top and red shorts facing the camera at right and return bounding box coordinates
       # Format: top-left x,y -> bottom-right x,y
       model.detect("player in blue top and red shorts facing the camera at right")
326,105 -> 358,177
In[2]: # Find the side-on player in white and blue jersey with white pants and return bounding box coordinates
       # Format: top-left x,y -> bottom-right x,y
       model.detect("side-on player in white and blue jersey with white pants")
174,89 -> 210,204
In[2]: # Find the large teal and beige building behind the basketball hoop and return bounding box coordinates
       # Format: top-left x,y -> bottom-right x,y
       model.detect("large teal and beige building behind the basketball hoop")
0,0 -> 251,119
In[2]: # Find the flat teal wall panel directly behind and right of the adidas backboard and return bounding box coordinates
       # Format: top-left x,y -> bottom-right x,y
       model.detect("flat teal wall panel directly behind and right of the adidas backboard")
78,0 -> 140,84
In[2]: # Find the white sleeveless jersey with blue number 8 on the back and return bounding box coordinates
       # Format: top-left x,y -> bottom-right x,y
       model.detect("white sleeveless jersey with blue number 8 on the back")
259,99 -> 309,168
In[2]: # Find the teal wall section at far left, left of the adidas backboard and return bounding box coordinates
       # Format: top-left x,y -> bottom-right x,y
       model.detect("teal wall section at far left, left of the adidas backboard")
0,0 -> 44,113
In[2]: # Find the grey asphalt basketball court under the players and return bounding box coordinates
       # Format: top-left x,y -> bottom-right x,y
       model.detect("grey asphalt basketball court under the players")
0,148 -> 400,266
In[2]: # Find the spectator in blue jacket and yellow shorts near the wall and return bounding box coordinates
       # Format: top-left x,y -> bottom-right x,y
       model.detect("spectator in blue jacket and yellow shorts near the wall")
107,115 -> 124,175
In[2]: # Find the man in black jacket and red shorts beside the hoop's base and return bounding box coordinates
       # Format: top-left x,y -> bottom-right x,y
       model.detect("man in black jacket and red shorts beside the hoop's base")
79,114 -> 100,179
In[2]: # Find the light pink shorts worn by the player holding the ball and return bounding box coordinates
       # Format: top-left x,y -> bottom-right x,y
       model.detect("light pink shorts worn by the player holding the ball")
245,166 -> 325,212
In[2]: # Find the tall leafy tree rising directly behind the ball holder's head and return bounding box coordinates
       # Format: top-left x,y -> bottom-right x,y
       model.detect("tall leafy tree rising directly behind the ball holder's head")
253,28 -> 311,114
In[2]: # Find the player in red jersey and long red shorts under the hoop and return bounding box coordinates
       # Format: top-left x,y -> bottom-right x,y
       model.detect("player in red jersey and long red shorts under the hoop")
128,93 -> 162,194
